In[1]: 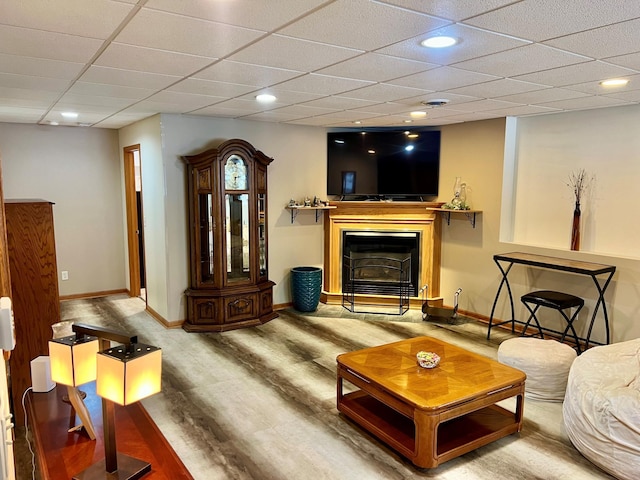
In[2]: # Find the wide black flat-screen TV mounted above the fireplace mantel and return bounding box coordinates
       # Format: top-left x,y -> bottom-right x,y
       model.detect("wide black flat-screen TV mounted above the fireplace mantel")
327,130 -> 440,199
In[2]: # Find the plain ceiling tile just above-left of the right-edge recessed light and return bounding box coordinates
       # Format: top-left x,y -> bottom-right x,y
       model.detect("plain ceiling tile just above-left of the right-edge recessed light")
517,60 -> 636,87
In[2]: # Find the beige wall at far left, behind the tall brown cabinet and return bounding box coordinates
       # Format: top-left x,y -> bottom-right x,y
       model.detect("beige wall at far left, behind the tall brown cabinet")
0,123 -> 126,296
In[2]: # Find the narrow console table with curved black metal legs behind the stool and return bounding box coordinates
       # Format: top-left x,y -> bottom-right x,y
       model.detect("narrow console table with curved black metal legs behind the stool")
487,252 -> 616,349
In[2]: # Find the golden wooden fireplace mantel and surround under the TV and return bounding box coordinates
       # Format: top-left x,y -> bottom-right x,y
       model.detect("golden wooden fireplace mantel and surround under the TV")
321,201 -> 442,308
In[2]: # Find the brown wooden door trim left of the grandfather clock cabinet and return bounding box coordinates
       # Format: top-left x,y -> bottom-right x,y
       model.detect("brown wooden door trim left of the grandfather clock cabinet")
123,144 -> 146,301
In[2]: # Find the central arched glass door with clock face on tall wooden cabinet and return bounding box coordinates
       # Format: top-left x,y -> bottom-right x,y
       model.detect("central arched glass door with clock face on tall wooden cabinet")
224,154 -> 251,283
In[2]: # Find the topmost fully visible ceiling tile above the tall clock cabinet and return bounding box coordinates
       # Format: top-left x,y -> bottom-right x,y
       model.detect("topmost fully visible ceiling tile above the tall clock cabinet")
115,8 -> 264,58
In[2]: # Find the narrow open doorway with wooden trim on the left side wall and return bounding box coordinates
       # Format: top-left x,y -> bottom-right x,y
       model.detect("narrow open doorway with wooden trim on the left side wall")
124,145 -> 147,302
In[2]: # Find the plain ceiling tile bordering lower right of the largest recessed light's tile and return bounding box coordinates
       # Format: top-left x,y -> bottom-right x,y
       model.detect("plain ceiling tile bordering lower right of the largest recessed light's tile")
456,44 -> 590,77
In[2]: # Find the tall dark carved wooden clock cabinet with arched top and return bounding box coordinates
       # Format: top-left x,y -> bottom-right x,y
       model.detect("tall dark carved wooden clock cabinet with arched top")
183,139 -> 278,332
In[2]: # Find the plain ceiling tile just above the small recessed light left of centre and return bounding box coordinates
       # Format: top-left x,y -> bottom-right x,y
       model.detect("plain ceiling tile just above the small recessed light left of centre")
194,60 -> 303,87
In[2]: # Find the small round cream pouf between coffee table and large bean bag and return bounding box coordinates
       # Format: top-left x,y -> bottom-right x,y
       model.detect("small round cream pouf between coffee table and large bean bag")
498,337 -> 576,402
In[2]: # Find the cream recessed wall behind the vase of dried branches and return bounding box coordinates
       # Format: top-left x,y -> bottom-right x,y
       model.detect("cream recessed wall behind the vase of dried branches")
511,105 -> 640,259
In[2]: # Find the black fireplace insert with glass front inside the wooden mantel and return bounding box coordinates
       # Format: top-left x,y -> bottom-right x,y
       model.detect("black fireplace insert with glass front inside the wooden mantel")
342,230 -> 420,297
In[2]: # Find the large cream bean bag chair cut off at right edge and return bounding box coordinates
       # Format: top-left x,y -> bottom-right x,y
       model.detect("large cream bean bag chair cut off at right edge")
563,338 -> 640,480
